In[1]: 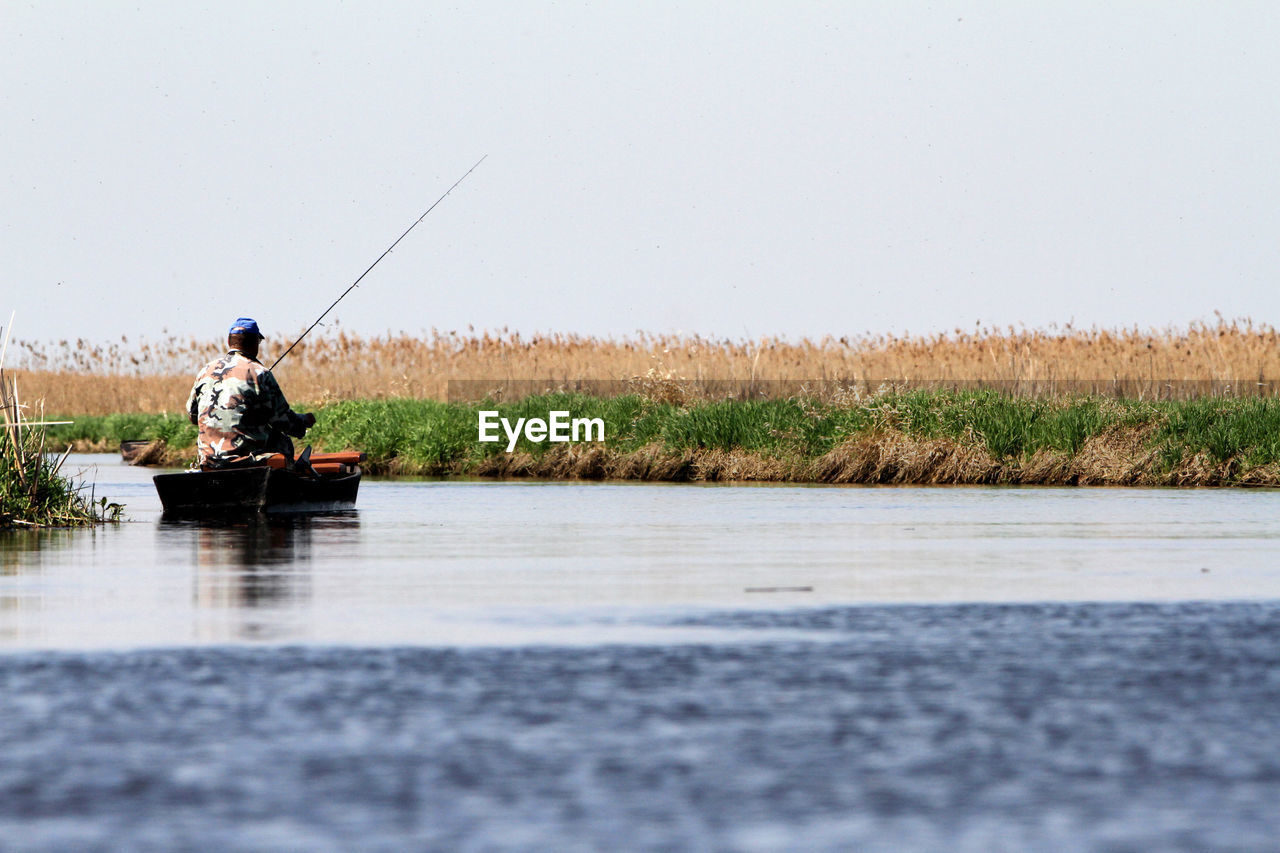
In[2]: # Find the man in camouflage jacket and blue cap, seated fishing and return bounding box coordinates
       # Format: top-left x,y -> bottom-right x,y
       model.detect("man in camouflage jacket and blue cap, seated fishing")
187,316 -> 316,470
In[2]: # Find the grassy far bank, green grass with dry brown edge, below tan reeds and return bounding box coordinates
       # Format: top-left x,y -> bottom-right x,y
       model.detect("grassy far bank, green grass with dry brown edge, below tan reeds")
49,392 -> 1280,485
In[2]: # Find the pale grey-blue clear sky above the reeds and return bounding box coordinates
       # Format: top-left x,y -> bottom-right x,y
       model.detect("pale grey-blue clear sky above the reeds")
0,0 -> 1280,341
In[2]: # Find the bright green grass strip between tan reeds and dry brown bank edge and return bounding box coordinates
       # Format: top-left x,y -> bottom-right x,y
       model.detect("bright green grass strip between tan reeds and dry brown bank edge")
50,391 -> 1280,474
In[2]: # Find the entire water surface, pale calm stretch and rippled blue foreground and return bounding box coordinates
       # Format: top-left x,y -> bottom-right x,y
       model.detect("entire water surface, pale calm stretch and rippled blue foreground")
0,456 -> 1280,850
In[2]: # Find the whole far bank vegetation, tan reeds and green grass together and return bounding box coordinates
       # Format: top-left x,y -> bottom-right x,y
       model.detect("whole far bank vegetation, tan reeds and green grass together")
17,318 -> 1280,485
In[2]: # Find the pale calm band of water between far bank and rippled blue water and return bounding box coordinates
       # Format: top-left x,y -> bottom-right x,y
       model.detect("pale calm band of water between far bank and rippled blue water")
0,457 -> 1280,648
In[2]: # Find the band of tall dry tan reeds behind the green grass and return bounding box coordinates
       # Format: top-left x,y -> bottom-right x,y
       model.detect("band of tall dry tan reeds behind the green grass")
17,319 -> 1280,415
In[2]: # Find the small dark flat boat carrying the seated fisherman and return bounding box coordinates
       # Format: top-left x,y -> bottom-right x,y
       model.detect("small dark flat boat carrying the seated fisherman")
152,448 -> 365,516
